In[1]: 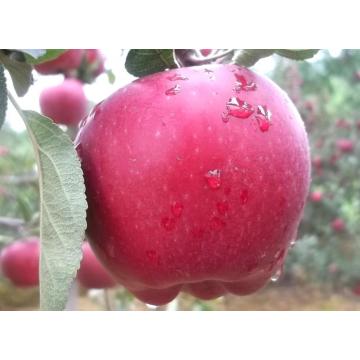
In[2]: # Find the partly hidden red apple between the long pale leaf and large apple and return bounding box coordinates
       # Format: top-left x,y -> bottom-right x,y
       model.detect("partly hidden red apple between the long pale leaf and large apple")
77,242 -> 116,289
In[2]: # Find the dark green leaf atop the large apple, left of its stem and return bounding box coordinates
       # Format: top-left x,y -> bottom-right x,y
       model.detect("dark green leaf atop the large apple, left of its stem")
125,49 -> 177,77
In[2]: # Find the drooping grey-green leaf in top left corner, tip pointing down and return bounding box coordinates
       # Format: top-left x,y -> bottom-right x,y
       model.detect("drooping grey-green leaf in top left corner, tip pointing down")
0,51 -> 33,96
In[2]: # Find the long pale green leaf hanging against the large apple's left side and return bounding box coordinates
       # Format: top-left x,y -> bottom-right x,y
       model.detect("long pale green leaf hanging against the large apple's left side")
10,98 -> 87,310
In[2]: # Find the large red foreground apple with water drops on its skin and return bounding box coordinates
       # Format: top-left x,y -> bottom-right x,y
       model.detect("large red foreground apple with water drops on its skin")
75,65 -> 310,305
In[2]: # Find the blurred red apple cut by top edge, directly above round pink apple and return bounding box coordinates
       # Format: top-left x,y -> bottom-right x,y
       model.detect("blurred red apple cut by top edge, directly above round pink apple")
34,49 -> 84,75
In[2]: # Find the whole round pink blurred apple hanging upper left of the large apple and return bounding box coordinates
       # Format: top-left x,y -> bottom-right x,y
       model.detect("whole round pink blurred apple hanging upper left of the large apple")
40,79 -> 87,126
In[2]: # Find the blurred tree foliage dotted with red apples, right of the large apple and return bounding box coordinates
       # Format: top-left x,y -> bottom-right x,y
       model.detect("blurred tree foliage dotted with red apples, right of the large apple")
273,50 -> 360,288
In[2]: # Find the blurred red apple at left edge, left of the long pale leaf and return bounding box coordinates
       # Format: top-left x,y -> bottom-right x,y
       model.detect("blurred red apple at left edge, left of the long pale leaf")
0,237 -> 40,287
